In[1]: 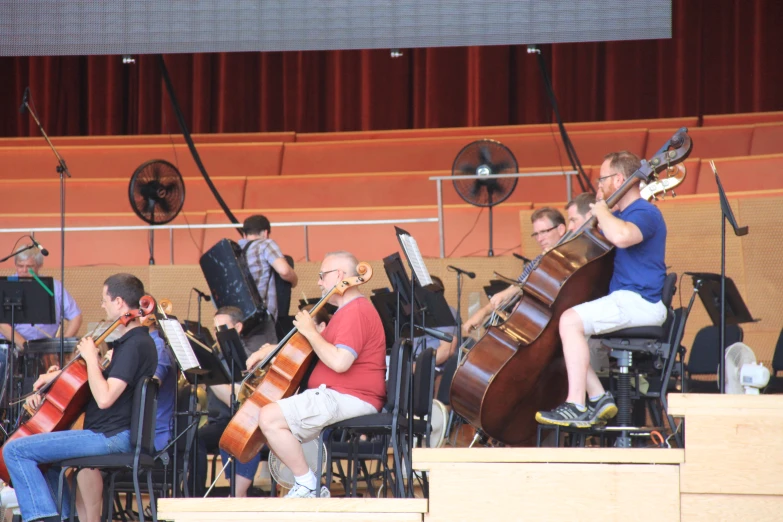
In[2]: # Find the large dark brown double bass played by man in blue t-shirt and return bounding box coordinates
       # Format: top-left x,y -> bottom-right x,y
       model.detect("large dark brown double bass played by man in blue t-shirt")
450,127 -> 692,446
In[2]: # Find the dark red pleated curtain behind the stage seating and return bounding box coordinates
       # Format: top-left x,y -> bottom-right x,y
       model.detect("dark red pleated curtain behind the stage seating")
0,0 -> 783,136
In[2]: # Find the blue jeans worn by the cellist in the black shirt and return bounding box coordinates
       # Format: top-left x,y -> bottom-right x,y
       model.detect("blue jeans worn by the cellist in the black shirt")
3,430 -> 131,522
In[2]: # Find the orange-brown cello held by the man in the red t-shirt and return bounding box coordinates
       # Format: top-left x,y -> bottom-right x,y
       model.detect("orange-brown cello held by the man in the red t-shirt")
220,262 -> 372,463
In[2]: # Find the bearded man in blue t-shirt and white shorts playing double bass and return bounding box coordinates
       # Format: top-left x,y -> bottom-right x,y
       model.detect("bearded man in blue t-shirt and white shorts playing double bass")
536,151 -> 666,427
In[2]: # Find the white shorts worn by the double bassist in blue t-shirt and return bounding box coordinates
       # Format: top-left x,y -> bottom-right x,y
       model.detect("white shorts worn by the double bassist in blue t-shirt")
573,290 -> 666,335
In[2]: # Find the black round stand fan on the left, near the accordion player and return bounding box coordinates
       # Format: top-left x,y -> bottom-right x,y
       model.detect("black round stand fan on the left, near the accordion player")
128,160 -> 185,265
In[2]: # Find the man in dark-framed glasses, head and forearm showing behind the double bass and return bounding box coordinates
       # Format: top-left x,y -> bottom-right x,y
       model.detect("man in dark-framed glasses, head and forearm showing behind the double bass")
462,207 -> 566,335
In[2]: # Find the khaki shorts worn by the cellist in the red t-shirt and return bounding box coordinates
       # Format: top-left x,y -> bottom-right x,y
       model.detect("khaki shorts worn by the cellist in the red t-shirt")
277,384 -> 378,443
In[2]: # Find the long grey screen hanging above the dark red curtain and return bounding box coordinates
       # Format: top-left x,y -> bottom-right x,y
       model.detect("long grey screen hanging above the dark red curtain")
0,0 -> 672,56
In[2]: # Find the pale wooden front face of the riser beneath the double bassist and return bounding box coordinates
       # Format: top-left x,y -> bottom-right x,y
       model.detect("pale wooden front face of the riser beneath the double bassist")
425,460 -> 680,522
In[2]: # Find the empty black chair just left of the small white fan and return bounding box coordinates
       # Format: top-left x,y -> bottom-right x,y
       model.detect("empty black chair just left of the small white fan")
683,324 -> 744,393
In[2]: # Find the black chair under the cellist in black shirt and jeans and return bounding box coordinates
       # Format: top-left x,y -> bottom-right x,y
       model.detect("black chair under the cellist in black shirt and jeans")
56,378 -> 158,522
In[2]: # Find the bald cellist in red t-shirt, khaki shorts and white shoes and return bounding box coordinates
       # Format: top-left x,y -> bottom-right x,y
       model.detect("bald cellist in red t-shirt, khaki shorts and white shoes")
254,252 -> 386,498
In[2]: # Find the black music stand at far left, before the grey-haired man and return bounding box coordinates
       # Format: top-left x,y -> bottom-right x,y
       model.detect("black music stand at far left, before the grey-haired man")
0,276 -> 56,435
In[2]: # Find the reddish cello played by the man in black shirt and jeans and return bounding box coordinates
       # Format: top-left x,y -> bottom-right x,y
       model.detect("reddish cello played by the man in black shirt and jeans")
0,295 -> 155,484
